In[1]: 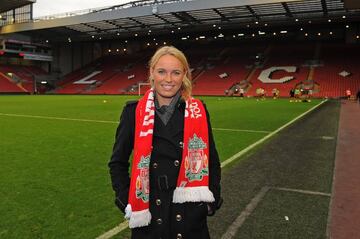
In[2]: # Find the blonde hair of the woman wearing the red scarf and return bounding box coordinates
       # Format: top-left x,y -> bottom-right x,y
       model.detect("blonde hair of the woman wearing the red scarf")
149,46 -> 192,100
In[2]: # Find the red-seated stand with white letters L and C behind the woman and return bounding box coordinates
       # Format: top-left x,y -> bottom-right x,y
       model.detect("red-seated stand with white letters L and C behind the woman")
43,43 -> 360,97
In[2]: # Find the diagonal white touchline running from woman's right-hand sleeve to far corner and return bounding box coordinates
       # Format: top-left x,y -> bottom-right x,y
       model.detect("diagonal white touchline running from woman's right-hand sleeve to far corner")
221,100 -> 327,167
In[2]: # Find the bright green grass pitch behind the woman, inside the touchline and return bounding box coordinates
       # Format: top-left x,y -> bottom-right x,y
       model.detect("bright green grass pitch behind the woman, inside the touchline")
0,96 -> 320,239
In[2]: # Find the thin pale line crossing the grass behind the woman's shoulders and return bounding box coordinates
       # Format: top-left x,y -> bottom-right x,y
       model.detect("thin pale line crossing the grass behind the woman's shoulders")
0,113 -> 271,134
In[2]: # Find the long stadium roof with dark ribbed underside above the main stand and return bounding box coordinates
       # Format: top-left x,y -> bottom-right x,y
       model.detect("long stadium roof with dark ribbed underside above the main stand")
0,0 -> 360,41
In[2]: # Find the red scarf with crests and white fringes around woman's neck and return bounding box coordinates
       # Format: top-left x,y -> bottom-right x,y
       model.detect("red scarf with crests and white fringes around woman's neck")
125,89 -> 215,228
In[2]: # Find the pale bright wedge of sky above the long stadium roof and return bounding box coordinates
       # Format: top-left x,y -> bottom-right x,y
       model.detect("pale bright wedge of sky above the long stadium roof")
34,0 -> 131,18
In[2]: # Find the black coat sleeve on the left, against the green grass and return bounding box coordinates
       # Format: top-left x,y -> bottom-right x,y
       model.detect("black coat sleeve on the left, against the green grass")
108,105 -> 135,212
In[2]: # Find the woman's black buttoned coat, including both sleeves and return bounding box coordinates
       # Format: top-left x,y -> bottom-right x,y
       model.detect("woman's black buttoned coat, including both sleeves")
109,100 -> 221,239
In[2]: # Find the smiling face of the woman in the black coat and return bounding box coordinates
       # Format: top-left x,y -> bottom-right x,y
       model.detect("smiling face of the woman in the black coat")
151,55 -> 186,106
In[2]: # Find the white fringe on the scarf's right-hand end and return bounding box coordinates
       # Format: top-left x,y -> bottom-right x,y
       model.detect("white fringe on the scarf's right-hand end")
173,186 -> 215,203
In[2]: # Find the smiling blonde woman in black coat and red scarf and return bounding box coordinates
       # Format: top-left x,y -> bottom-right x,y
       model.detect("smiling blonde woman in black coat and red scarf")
109,46 -> 221,239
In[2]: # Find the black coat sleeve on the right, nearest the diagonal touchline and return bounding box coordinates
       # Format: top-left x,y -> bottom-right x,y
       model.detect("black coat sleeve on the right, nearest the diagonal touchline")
204,105 -> 222,216
